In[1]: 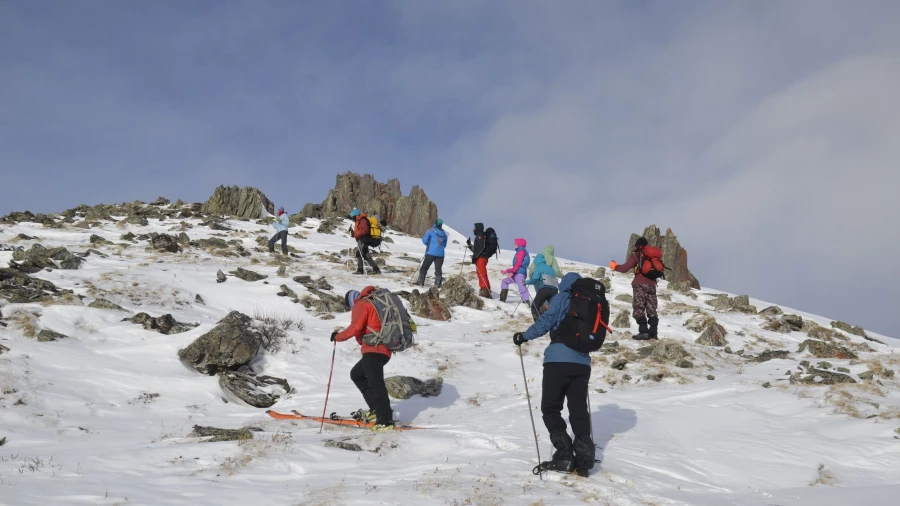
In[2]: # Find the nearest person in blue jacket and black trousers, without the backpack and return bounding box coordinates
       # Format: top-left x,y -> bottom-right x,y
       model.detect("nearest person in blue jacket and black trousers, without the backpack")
513,272 -> 595,476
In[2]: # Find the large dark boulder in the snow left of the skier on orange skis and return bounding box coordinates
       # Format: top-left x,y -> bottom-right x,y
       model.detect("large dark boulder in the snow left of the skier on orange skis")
178,311 -> 262,376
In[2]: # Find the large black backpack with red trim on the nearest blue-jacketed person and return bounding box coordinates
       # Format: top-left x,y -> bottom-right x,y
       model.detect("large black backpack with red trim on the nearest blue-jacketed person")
550,278 -> 612,353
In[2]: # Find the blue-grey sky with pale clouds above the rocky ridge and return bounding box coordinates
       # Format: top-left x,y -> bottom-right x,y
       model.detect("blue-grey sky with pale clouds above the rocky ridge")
0,0 -> 900,337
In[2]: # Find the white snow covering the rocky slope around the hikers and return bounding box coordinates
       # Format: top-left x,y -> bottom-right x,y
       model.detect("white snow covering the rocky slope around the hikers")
0,211 -> 900,506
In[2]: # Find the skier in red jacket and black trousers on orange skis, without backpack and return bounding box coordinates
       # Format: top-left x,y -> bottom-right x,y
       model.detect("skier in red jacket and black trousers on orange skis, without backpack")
331,286 -> 394,427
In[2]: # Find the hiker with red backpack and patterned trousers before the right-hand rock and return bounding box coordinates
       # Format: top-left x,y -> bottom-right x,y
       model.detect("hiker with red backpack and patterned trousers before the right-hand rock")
609,237 -> 665,341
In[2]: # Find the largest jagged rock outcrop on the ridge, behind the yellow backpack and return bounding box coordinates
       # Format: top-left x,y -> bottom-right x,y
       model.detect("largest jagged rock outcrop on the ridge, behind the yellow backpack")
300,172 -> 438,235
